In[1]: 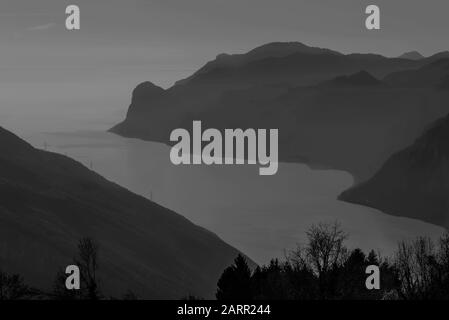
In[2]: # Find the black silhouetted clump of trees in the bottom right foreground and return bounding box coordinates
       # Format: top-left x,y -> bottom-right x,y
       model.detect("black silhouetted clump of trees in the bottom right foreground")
216,223 -> 449,300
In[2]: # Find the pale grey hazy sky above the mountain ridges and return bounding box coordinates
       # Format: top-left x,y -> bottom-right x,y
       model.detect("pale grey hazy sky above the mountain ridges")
0,0 -> 449,134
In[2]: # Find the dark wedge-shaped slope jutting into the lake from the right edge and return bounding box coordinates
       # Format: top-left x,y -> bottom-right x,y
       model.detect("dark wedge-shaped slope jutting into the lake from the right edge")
340,112 -> 449,228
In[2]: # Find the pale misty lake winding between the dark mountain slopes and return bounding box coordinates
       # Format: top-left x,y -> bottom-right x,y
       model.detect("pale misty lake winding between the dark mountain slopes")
24,131 -> 444,263
